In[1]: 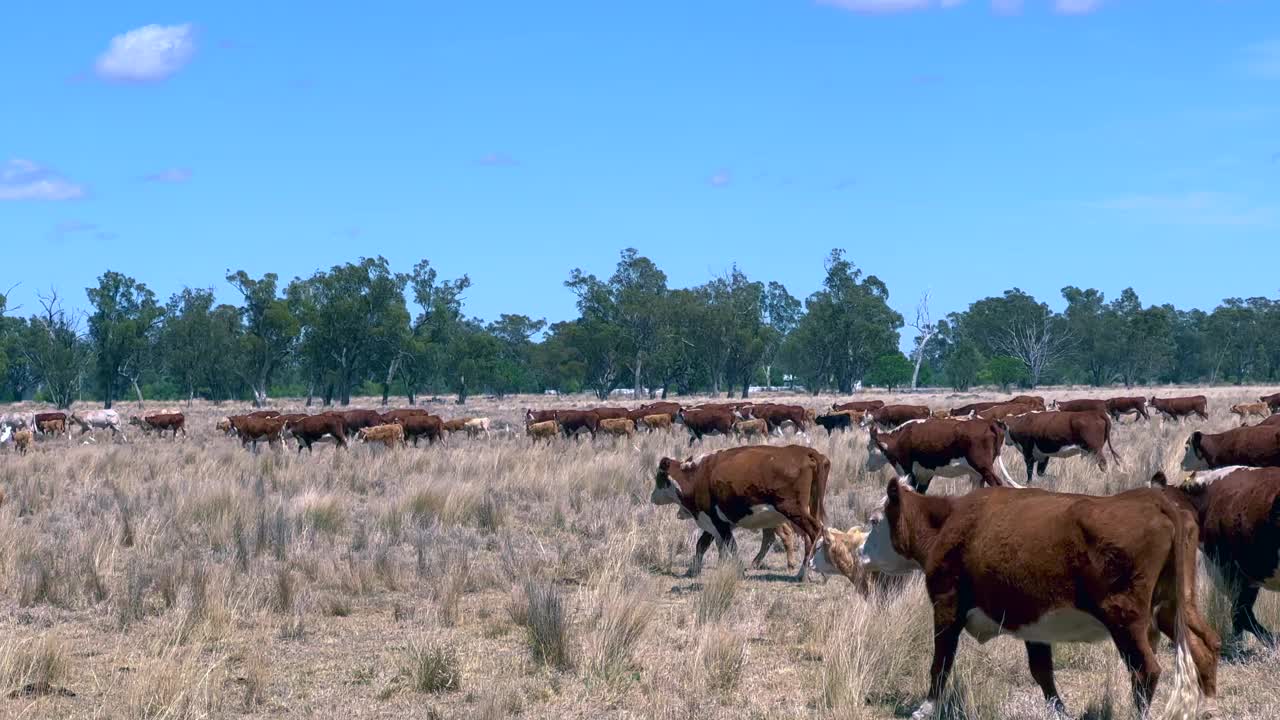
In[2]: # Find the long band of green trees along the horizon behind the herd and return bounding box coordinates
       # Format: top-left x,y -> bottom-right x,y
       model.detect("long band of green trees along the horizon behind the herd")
0,249 -> 1280,407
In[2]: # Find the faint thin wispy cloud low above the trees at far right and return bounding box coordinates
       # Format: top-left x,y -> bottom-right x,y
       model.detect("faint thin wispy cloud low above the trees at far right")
1089,191 -> 1277,225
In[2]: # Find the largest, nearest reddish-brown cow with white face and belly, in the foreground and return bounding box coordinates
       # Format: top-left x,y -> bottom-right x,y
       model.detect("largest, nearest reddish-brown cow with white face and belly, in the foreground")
861,480 -> 1221,720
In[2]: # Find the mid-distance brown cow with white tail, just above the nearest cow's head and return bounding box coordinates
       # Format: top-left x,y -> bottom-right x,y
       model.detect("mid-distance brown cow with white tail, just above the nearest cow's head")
867,419 -> 1020,492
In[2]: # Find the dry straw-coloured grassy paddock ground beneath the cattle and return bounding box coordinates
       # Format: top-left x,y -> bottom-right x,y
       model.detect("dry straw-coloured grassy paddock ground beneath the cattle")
0,388 -> 1280,720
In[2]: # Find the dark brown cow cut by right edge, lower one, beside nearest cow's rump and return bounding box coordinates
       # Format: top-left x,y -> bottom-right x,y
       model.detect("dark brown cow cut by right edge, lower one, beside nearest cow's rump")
1151,468 -> 1280,647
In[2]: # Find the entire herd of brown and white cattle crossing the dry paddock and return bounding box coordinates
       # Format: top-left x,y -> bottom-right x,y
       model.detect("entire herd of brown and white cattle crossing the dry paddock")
0,393 -> 1280,719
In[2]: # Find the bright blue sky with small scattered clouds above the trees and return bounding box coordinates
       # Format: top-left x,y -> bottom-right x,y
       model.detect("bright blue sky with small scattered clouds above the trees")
0,0 -> 1280,340
